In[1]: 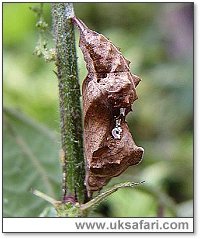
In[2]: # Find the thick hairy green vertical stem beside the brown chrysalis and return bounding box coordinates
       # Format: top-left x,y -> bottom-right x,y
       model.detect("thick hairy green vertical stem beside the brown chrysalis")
52,3 -> 85,203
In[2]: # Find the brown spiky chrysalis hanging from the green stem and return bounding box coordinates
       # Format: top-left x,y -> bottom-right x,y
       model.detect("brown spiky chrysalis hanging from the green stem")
73,17 -> 144,195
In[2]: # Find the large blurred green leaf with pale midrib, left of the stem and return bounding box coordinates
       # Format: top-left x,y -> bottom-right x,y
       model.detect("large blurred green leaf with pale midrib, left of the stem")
3,108 -> 61,217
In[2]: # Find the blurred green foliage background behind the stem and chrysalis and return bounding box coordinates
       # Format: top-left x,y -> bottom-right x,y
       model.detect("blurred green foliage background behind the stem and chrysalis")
3,3 -> 193,217
